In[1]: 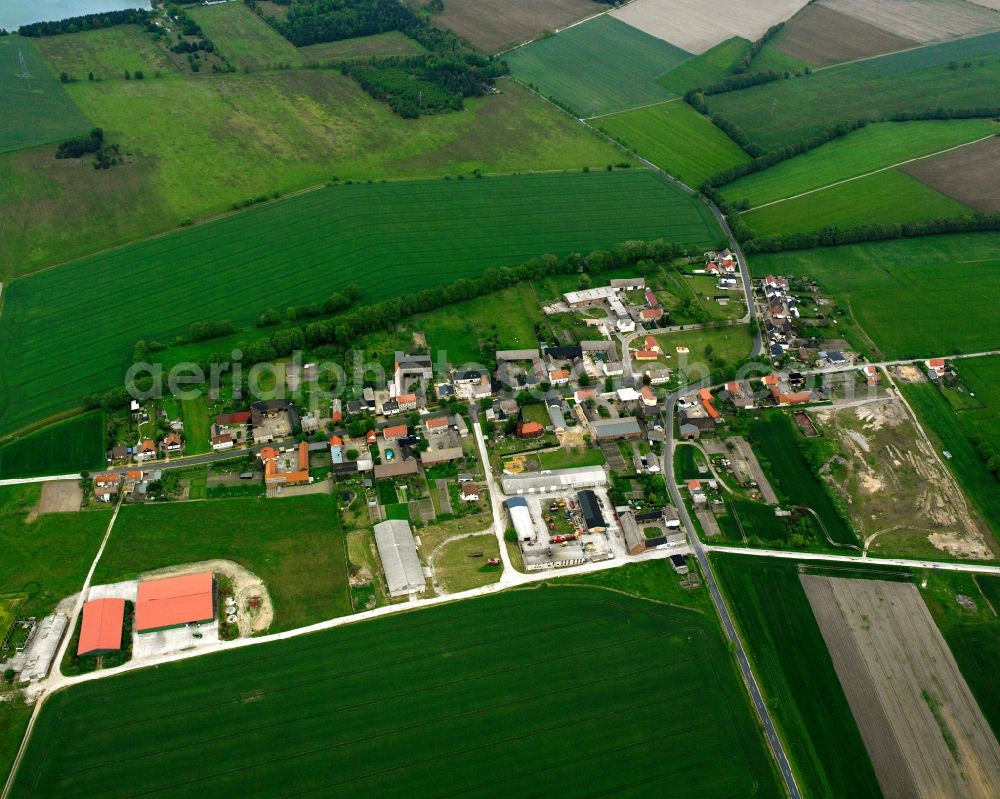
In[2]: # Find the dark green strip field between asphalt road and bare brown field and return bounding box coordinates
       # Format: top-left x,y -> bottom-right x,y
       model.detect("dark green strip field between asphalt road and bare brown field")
711,554 -> 882,799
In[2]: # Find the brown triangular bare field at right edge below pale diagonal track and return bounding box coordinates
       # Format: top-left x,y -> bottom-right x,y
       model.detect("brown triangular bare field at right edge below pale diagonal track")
902,136 -> 1000,213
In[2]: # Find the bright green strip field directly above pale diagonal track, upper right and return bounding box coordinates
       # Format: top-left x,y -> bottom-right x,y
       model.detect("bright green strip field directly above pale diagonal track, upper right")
720,119 -> 997,208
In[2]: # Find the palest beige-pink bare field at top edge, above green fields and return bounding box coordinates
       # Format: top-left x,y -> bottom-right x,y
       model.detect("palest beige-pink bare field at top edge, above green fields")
611,0 -> 806,54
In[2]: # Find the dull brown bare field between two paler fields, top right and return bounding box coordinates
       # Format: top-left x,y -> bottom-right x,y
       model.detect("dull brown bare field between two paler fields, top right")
774,3 -> 919,67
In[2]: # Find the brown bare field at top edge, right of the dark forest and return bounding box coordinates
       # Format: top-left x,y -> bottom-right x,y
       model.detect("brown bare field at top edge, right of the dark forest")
424,0 -> 607,53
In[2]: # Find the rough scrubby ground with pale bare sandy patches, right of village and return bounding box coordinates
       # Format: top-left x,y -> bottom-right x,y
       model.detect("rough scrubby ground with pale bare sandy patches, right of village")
816,400 -> 993,559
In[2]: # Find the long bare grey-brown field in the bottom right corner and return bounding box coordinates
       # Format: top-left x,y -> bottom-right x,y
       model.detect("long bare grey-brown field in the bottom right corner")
800,575 -> 1000,799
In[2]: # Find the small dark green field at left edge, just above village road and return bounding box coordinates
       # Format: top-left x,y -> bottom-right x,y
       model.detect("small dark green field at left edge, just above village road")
0,411 -> 107,479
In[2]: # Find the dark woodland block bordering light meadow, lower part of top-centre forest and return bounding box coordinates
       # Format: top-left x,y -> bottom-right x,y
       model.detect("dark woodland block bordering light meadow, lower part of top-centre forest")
340,52 -> 506,119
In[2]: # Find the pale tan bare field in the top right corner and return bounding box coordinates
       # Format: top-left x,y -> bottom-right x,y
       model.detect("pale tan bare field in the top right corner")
820,0 -> 1000,42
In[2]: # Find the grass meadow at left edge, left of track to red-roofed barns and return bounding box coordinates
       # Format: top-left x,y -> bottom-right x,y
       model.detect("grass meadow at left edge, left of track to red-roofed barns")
0,510 -> 111,620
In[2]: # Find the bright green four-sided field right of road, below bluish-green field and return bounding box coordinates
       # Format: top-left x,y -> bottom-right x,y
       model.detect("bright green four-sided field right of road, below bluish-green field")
593,100 -> 750,188
